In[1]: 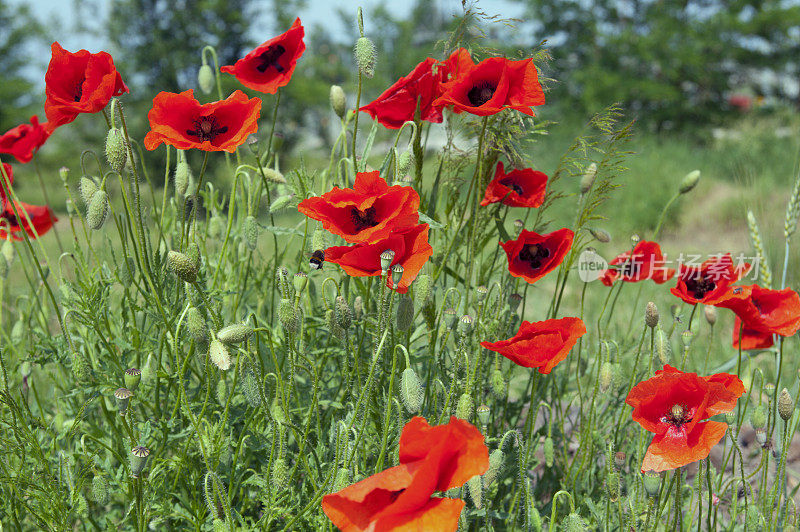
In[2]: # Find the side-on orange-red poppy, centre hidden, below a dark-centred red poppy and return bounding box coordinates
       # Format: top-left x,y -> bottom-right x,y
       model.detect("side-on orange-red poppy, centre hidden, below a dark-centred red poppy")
481,318 -> 586,374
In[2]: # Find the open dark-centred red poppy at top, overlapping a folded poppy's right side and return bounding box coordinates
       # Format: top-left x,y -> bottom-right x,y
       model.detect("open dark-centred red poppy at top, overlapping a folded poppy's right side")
434,57 -> 544,116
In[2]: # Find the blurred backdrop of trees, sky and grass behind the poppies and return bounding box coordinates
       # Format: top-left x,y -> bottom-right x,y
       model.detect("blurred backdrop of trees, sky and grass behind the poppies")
0,0 -> 800,260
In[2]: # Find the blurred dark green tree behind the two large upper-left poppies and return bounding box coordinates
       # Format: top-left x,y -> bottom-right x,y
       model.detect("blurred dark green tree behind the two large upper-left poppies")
106,0 -> 261,98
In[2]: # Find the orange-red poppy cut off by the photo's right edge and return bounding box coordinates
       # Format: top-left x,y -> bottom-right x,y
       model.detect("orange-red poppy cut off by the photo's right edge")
716,285 -> 800,336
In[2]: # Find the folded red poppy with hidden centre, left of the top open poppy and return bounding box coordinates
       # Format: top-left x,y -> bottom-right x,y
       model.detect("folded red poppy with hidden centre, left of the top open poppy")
359,57 -> 442,129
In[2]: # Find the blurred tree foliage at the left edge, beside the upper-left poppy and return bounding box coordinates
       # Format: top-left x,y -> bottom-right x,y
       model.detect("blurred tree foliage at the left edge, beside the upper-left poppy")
0,0 -> 44,133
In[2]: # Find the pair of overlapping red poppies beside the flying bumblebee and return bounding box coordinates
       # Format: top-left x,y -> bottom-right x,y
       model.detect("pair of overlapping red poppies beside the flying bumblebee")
297,171 -> 433,293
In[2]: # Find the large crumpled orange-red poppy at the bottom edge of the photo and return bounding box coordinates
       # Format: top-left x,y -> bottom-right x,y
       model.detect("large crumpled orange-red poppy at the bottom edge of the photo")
322,417 -> 489,532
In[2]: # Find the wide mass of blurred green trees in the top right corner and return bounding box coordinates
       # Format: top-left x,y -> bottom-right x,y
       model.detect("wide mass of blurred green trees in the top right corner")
516,0 -> 800,129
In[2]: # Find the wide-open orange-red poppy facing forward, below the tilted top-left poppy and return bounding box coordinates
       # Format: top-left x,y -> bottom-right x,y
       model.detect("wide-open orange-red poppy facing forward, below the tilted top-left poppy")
144,90 -> 261,153
